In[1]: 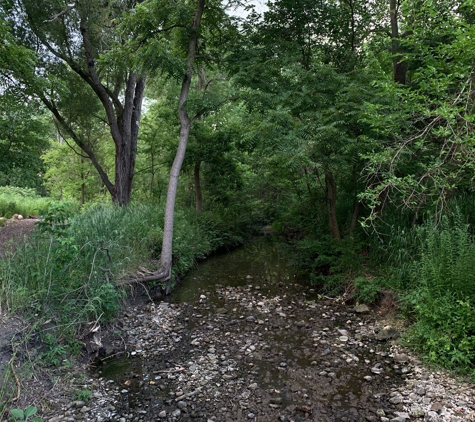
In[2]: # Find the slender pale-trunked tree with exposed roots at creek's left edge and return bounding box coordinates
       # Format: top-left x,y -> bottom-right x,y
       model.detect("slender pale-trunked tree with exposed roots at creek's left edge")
115,0 -> 205,292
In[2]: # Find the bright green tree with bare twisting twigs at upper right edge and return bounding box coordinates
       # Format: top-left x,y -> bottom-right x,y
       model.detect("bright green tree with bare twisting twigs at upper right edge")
362,1 -> 475,221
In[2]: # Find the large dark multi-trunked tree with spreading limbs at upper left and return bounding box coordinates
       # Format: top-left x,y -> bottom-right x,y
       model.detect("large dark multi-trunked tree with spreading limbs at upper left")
1,0 -> 146,205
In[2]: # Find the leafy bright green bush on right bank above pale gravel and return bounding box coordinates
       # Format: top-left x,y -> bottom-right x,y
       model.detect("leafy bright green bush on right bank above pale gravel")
404,215 -> 475,373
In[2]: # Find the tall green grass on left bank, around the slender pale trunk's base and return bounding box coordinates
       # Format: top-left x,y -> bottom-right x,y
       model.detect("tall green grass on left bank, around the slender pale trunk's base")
0,204 -> 242,336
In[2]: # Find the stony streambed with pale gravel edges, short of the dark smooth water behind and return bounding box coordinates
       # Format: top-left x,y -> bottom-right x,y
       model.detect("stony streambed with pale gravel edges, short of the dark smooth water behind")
45,241 -> 475,422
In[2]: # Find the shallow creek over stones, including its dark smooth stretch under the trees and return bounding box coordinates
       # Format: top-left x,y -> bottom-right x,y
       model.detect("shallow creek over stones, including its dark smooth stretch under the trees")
94,236 -> 411,422
